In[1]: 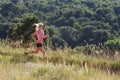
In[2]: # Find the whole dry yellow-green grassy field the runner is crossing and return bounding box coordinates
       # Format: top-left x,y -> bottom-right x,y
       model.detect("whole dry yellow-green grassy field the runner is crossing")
0,43 -> 120,80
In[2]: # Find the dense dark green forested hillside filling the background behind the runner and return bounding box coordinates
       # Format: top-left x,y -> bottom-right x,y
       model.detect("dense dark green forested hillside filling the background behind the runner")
0,0 -> 120,47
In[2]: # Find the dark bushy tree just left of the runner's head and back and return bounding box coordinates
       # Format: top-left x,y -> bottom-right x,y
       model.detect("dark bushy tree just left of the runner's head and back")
8,14 -> 39,41
